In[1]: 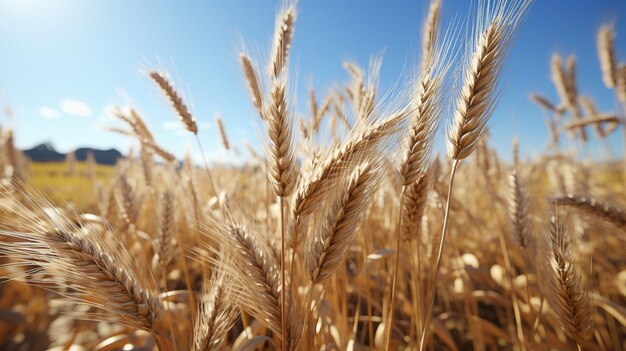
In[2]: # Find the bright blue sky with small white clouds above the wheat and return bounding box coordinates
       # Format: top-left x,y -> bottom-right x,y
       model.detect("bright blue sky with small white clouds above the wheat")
0,0 -> 626,164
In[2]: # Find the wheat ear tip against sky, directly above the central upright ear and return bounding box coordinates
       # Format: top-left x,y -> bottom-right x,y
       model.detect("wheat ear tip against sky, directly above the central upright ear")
269,4 -> 296,78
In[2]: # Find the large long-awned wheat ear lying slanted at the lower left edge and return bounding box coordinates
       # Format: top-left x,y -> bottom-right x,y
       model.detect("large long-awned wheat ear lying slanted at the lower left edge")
0,224 -> 162,333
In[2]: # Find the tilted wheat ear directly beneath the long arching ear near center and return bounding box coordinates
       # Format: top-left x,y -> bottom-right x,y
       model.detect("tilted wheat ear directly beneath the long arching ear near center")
304,163 -> 378,284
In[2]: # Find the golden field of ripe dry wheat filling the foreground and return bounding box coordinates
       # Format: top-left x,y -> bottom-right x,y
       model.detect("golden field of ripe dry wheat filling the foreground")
0,0 -> 626,351
